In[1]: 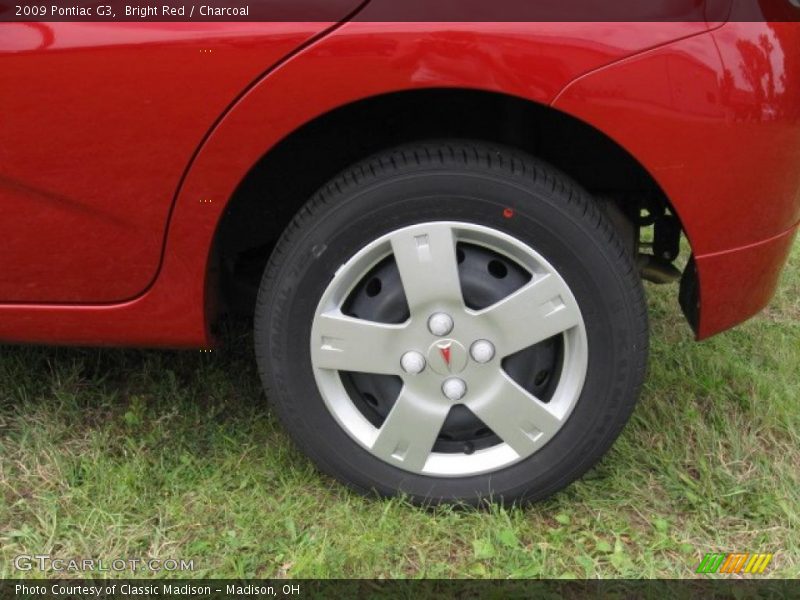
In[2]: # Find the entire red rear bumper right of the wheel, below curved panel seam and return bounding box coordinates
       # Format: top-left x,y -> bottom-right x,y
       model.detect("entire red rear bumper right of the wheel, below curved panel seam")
553,21 -> 800,339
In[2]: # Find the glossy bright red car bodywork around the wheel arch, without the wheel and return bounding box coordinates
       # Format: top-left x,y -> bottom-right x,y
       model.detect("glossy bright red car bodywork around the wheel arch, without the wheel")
0,9 -> 800,347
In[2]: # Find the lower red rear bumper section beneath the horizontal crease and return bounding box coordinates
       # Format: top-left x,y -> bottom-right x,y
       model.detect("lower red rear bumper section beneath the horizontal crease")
682,223 -> 800,340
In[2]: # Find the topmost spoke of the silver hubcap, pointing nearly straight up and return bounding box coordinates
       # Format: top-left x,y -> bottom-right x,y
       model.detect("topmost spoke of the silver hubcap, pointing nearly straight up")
391,223 -> 463,314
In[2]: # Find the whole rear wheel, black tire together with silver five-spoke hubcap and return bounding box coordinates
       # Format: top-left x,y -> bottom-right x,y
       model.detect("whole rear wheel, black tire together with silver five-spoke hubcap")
255,143 -> 647,503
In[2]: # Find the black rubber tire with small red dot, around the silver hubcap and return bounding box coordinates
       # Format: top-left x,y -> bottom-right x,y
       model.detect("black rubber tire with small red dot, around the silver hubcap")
255,141 -> 648,504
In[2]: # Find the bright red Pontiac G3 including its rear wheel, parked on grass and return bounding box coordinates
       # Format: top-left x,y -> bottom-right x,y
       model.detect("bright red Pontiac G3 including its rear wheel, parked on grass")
0,0 -> 800,503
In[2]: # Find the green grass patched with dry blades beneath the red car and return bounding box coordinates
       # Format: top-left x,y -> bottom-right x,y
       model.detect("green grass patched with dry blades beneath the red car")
0,244 -> 800,577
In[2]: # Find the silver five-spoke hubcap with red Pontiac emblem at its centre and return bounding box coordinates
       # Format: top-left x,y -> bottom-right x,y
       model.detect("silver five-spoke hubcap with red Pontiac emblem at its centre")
311,222 -> 588,476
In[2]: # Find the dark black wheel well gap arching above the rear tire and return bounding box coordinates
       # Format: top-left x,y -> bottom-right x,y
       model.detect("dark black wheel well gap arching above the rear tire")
215,89 -> 688,314
